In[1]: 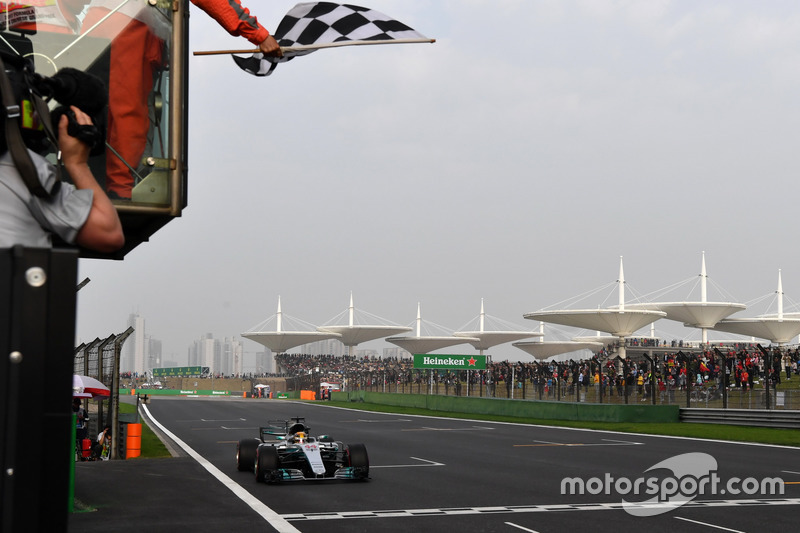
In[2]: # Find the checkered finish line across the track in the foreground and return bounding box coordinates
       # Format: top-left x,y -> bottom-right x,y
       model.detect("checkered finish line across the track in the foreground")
280,498 -> 800,522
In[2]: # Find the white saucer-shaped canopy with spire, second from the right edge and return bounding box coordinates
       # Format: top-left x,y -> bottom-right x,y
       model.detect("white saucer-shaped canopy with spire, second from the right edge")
628,252 -> 747,344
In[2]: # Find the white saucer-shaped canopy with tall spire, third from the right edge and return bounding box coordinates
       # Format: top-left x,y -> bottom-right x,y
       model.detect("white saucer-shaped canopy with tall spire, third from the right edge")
523,257 -> 667,358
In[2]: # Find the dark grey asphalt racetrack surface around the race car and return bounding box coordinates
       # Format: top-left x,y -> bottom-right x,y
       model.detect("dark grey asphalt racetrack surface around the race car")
69,397 -> 800,533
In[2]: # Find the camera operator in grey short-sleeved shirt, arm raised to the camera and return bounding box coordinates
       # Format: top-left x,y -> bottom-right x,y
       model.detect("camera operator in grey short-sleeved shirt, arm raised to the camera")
0,106 -> 125,252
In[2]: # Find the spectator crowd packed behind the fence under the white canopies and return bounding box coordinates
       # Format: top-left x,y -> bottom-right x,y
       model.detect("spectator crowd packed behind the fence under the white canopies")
276,344 -> 800,401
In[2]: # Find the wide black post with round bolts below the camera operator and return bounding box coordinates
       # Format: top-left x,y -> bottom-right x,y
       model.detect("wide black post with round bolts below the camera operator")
0,247 -> 78,533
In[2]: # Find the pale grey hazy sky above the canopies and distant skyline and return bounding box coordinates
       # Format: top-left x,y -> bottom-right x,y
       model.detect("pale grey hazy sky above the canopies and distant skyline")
78,0 -> 800,366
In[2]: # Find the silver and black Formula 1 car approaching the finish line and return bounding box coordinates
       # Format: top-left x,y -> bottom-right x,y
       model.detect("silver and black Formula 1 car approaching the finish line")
236,417 -> 369,483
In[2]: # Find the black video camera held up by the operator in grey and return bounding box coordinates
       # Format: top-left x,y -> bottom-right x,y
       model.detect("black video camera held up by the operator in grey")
0,51 -> 108,155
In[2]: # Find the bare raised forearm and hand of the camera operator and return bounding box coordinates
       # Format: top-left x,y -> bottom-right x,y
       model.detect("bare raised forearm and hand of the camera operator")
58,106 -> 125,253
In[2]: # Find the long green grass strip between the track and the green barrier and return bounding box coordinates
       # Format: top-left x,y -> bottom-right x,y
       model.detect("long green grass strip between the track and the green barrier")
325,401 -> 800,446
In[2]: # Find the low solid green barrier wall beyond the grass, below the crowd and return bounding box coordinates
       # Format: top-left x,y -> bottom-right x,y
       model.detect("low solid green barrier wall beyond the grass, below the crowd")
331,391 -> 680,422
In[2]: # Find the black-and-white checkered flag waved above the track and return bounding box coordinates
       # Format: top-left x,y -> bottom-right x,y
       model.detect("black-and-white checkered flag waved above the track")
233,2 -> 434,76
